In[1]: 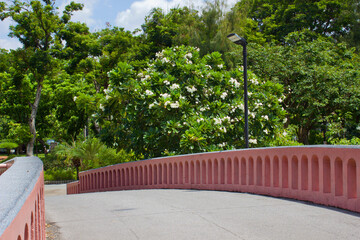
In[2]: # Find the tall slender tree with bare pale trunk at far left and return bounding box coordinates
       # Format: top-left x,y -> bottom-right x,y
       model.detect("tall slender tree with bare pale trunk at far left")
0,0 -> 82,156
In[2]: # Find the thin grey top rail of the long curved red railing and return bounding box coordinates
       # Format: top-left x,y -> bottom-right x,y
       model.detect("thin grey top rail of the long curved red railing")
82,145 -> 360,173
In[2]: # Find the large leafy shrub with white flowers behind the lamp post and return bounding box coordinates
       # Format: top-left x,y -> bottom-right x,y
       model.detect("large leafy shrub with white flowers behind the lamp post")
100,46 -> 285,157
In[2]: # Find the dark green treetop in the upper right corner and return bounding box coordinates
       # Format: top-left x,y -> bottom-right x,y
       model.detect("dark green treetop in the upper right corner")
242,0 -> 359,42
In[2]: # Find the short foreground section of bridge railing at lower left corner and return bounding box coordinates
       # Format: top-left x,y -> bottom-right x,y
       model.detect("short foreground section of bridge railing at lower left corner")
0,157 -> 45,240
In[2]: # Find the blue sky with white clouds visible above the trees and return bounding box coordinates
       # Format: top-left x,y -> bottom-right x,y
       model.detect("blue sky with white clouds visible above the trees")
0,0 -> 237,49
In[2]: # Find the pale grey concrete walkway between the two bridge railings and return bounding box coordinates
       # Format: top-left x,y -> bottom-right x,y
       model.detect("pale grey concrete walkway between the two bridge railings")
45,186 -> 360,240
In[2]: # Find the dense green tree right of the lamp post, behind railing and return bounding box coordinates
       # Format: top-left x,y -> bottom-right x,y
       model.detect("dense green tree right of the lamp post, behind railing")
249,31 -> 360,144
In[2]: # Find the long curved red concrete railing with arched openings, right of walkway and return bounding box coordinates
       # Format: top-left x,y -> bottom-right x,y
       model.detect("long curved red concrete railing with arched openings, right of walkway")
68,146 -> 360,212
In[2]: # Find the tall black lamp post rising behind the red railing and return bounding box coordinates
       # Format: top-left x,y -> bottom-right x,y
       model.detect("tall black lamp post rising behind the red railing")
227,33 -> 249,148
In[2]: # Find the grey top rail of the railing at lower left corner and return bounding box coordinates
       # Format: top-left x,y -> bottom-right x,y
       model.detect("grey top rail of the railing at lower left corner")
0,157 -> 43,236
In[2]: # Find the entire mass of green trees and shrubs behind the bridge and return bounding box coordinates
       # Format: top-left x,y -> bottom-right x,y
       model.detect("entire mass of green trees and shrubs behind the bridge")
0,0 -> 360,163
